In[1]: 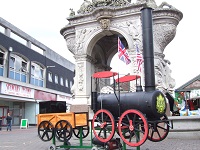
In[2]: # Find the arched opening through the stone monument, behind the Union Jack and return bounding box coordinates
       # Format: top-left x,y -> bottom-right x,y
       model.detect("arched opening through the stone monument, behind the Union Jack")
92,33 -> 129,74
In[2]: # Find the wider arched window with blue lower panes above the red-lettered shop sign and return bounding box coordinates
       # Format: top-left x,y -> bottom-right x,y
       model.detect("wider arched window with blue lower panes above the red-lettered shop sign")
9,54 -> 28,83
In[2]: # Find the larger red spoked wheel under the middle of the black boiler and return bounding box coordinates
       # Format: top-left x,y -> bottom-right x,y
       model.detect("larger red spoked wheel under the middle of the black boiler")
118,109 -> 149,147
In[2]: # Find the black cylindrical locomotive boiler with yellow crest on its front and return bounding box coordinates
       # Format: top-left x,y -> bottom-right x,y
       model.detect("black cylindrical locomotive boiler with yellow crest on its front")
94,90 -> 166,119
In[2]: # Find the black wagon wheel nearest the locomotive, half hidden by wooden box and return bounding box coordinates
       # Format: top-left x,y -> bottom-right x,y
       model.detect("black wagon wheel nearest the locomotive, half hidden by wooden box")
73,126 -> 90,138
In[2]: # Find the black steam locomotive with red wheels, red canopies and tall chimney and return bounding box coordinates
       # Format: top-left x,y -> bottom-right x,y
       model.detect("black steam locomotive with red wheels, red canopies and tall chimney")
91,8 -> 170,147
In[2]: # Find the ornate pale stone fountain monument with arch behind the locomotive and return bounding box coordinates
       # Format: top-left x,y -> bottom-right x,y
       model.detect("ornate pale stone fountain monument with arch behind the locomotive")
60,0 -> 183,109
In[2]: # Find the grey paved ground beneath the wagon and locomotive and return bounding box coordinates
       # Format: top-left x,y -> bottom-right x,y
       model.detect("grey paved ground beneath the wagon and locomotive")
0,127 -> 200,150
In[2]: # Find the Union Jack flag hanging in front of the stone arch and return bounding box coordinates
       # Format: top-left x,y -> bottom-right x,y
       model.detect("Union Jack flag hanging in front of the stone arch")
118,37 -> 131,65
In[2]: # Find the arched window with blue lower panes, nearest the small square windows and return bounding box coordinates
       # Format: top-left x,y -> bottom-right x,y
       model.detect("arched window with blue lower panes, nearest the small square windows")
31,63 -> 44,87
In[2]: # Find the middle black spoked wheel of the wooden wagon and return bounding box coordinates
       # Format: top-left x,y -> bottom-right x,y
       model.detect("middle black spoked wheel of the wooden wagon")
55,120 -> 72,142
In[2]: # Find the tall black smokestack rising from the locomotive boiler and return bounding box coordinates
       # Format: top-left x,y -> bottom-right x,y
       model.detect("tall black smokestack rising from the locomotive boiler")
141,6 -> 155,92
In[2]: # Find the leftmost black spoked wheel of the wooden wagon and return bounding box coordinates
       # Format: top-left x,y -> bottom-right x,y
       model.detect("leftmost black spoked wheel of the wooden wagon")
38,121 -> 54,142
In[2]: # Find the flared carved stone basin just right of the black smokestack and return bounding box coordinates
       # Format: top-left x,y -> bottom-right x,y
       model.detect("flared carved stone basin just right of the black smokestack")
153,9 -> 182,53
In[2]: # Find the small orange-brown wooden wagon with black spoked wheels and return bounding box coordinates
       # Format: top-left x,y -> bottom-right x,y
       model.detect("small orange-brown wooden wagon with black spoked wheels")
37,105 -> 90,148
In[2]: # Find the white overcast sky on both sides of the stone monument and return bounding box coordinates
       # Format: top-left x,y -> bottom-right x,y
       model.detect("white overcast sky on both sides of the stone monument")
0,0 -> 200,88
